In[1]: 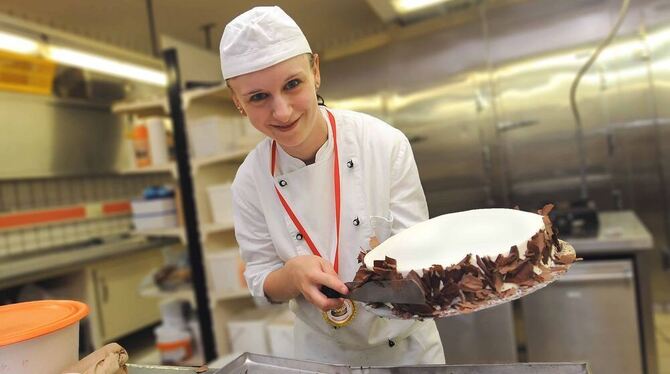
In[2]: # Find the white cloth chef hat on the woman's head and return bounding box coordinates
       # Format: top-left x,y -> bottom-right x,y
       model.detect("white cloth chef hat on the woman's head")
219,6 -> 312,79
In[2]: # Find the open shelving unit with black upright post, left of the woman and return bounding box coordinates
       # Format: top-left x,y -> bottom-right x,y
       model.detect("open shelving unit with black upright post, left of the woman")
112,50 -> 254,362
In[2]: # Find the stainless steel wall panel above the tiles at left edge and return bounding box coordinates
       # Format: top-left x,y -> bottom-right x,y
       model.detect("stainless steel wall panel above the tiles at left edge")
0,93 -> 125,179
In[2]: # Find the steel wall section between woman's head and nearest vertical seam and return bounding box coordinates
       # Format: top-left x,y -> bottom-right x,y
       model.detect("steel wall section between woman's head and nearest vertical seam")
323,14 -> 492,215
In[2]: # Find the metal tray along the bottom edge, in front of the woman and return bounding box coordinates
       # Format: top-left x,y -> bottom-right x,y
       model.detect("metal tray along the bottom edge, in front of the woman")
128,353 -> 590,374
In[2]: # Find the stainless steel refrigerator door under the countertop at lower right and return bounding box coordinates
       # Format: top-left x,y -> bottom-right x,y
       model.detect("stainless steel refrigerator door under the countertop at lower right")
521,260 -> 642,374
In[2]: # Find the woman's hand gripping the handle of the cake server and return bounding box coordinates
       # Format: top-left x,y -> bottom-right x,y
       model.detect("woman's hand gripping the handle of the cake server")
284,255 -> 349,311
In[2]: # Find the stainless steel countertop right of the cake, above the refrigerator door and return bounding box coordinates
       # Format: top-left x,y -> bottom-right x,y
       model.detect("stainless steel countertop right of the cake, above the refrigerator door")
559,210 -> 654,256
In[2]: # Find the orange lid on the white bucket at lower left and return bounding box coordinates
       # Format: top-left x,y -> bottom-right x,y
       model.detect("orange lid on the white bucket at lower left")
0,300 -> 88,347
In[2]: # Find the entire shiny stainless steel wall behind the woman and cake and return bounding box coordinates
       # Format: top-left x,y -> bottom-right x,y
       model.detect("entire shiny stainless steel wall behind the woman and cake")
323,0 -> 670,368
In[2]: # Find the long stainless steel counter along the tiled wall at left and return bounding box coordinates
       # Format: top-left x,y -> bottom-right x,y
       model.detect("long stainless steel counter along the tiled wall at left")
0,236 -> 176,289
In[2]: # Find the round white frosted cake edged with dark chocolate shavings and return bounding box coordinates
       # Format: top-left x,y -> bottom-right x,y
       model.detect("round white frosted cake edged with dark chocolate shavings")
355,205 -> 576,318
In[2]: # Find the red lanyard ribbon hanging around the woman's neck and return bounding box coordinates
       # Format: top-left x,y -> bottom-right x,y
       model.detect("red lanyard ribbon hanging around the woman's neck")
270,111 -> 340,273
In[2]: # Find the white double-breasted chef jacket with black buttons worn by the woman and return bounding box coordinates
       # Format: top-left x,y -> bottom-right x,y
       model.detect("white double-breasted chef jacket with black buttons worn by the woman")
232,108 -> 444,366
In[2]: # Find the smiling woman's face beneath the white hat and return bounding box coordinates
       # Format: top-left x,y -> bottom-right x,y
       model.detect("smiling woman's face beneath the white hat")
228,54 -> 323,154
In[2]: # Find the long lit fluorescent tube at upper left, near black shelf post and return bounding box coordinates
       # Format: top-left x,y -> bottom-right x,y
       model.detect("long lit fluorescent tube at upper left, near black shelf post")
47,46 -> 167,86
